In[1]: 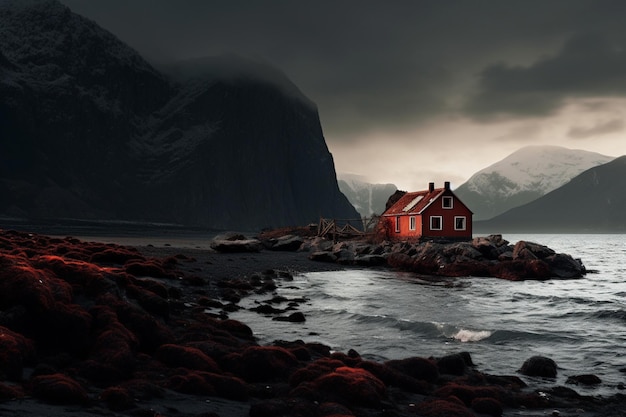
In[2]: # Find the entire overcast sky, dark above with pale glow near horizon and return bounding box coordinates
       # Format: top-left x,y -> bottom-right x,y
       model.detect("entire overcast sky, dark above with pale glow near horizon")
62,0 -> 626,190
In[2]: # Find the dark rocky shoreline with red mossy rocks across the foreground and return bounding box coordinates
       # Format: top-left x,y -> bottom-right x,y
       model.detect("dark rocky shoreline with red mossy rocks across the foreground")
0,230 -> 626,417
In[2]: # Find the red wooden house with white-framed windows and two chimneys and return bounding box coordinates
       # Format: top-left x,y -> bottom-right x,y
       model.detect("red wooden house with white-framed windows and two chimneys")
379,181 -> 473,240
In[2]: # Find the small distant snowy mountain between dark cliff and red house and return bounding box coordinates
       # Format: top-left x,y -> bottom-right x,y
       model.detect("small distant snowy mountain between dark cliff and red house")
337,173 -> 398,217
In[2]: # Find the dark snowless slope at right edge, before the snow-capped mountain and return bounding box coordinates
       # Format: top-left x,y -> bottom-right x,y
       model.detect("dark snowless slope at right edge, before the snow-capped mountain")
474,156 -> 626,233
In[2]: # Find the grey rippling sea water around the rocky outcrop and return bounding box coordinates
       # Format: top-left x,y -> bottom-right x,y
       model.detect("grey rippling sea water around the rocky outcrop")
231,234 -> 626,395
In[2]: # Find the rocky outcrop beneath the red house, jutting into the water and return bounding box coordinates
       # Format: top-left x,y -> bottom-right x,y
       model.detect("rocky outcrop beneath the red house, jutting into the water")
294,235 -> 586,281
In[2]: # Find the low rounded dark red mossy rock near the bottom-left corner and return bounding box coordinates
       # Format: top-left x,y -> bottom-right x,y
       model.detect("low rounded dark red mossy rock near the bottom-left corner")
30,374 -> 89,404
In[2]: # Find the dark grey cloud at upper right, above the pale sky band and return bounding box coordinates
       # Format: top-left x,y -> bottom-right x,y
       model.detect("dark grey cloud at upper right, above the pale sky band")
465,33 -> 626,119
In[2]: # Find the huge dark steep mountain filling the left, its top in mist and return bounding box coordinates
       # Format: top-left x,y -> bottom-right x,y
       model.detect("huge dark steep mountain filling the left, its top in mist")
0,0 -> 359,230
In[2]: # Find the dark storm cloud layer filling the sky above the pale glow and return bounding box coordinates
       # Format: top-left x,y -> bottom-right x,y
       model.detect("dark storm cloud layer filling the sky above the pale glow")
62,0 -> 626,137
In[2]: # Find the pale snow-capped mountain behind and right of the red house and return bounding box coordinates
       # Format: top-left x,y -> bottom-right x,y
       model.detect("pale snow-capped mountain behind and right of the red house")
454,146 -> 613,220
